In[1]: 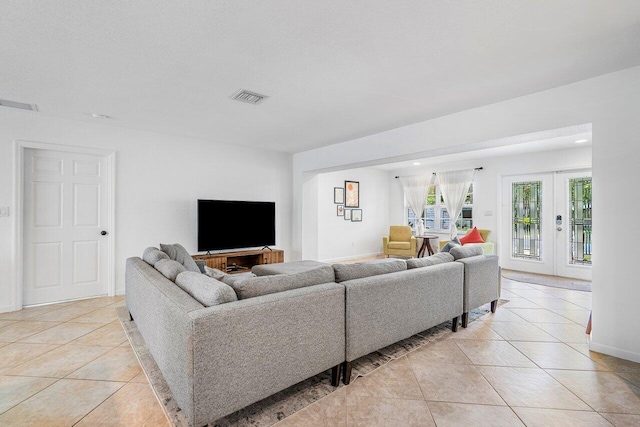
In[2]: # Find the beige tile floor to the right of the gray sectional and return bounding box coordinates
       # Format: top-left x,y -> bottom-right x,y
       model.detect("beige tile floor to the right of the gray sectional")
278,280 -> 640,427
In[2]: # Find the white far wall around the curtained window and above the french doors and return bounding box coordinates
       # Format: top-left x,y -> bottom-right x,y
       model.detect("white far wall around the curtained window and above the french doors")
389,146 -> 591,253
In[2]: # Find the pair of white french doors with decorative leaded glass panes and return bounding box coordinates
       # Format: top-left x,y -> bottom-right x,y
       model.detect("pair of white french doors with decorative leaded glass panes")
501,172 -> 591,280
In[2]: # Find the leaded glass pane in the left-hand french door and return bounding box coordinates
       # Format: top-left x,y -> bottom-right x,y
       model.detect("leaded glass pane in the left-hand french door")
511,181 -> 542,261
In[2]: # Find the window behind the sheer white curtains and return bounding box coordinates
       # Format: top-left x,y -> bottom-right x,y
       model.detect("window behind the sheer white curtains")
407,184 -> 473,231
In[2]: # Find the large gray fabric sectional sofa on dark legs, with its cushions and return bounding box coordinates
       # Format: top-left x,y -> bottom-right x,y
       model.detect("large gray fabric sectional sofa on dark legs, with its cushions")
126,245 -> 499,426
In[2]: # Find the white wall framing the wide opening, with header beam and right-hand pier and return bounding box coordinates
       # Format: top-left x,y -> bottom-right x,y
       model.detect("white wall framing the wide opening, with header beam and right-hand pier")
292,67 -> 640,362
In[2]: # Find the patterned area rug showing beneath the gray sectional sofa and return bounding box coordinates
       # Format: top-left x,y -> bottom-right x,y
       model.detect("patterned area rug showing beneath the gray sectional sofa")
116,300 -> 507,427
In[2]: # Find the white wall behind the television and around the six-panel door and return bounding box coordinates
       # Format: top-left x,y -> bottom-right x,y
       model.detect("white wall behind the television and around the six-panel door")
0,107 -> 292,311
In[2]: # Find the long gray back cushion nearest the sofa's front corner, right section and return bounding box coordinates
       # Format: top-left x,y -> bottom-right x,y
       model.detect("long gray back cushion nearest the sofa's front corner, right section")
225,265 -> 334,299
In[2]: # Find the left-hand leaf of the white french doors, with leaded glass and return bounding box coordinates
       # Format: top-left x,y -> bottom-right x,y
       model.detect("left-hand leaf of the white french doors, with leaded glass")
500,173 -> 555,274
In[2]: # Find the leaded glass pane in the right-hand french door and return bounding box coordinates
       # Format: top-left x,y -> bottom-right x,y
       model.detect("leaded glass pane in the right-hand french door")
569,178 -> 591,265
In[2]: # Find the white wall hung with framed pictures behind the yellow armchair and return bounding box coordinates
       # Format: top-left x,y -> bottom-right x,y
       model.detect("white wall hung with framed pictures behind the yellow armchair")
314,168 -> 389,262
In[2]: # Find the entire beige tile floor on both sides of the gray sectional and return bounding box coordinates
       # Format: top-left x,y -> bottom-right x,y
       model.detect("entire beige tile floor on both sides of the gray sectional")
0,280 -> 640,427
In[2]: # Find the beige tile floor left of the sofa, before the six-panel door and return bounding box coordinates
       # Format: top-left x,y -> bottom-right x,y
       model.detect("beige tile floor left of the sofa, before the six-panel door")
0,296 -> 169,426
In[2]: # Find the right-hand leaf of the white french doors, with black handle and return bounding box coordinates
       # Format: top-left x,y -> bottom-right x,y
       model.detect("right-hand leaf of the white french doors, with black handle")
555,171 -> 592,280
